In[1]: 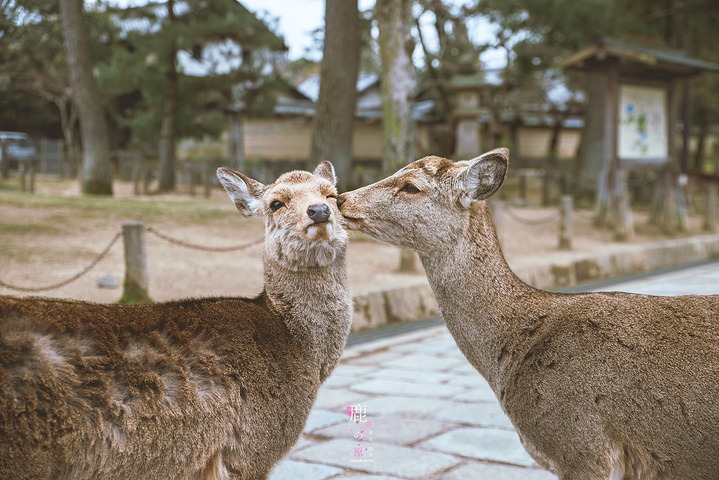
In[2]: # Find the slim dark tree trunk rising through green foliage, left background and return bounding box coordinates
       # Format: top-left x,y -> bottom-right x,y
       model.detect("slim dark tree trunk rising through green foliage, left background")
157,0 -> 178,192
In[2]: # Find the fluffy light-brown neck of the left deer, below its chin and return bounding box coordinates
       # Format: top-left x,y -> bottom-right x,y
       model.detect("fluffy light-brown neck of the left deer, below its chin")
264,249 -> 352,381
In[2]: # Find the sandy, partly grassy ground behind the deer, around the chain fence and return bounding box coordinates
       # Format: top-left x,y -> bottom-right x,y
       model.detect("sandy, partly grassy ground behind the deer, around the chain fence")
0,176 -> 701,302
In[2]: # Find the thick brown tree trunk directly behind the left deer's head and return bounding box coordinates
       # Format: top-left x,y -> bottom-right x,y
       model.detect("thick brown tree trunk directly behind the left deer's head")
310,0 -> 360,191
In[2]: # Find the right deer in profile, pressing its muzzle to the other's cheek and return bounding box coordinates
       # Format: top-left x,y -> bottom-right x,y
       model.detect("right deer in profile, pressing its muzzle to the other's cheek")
339,149 -> 719,480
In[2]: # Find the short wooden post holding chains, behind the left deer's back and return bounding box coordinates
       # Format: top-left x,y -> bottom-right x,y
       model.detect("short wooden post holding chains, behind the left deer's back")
118,222 -> 152,305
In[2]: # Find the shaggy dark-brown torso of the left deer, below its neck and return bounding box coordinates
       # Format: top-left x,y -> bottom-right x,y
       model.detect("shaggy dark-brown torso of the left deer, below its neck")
0,297 -> 319,478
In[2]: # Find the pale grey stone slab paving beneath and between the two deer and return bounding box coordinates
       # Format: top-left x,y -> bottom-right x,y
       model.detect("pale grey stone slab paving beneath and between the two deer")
270,263 -> 719,480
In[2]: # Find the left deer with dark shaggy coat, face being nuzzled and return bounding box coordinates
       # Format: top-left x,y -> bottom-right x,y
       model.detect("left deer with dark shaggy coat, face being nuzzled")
0,162 -> 352,480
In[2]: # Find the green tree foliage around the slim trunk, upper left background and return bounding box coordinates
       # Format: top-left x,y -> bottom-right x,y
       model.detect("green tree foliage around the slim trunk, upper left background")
98,0 -> 284,146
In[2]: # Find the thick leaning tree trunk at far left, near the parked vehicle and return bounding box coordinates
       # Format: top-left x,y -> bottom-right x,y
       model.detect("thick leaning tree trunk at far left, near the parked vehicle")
59,0 -> 112,195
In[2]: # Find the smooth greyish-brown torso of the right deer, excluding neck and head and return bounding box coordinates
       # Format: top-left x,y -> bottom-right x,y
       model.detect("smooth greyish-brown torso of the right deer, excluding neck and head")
498,293 -> 719,478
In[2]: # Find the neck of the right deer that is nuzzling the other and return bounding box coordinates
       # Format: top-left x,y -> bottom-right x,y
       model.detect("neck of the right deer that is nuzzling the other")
420,204 -> 536,392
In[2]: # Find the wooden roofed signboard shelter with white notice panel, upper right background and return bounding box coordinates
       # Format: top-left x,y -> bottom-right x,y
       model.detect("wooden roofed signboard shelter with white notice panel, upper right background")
560,38 -> 719,239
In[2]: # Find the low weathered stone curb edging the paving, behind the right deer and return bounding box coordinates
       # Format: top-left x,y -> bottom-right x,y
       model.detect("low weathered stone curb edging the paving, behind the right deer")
352,233 -> 719,331
